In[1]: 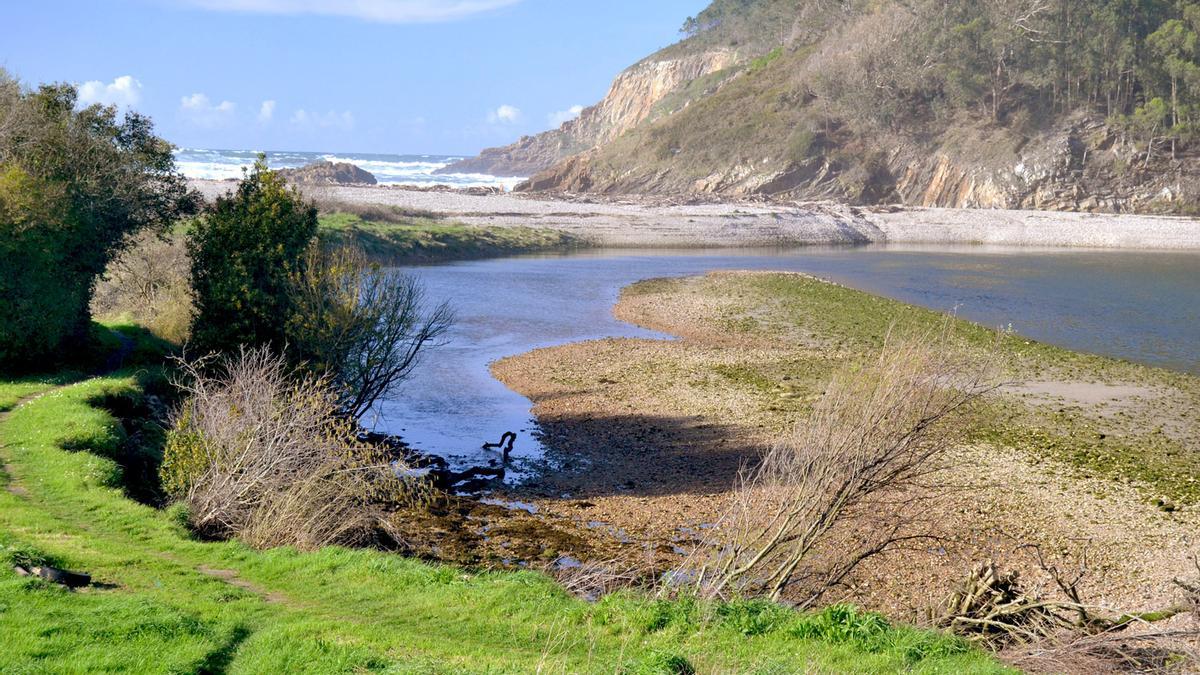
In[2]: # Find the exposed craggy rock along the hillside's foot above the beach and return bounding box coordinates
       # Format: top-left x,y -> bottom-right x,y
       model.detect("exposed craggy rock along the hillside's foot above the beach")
518,103 -> 1200,213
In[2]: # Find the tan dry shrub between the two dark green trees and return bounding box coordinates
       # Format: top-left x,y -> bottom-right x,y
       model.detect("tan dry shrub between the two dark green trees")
91,232 -> 192,345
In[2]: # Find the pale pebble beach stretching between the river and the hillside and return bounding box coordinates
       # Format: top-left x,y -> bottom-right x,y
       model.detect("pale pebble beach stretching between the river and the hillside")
190,180 -> 1200,251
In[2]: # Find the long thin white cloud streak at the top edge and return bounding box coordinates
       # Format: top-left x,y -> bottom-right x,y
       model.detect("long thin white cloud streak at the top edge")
175,0 -> 522,23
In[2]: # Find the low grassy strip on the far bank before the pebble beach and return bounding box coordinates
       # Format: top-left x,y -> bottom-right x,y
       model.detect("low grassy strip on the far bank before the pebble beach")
320,213 -> 586,264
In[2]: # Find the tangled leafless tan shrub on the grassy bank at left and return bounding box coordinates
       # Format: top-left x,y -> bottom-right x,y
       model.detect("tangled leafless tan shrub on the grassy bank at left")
162,348 -> 424,549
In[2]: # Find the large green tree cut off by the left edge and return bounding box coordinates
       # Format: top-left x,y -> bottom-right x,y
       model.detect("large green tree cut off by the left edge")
0,71 -> 198,369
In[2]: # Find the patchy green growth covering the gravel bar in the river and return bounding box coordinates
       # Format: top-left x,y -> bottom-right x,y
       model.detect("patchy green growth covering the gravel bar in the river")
625,274 -> 1200,502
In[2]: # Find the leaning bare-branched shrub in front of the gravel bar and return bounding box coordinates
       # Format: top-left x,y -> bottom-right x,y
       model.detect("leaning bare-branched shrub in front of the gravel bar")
689,324 -> 996,607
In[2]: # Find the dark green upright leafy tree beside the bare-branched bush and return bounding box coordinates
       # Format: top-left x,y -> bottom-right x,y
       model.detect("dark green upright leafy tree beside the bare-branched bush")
187,157 -> 317,352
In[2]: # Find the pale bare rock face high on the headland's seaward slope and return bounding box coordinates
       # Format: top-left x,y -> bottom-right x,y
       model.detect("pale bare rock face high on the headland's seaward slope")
438,49 -> 739,177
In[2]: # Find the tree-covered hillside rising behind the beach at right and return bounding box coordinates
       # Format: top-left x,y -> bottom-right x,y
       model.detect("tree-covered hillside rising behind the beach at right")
485,0 -> 1200,213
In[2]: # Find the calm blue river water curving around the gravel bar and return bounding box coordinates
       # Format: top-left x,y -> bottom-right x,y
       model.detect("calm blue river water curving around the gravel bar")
374,245 -> 1200,475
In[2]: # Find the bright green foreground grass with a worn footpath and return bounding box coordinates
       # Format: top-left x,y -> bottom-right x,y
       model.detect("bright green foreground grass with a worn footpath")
0,357 -> 1000,673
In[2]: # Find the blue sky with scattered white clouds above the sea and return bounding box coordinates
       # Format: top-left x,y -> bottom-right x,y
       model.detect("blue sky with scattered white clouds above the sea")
0,0 -> 708,155
